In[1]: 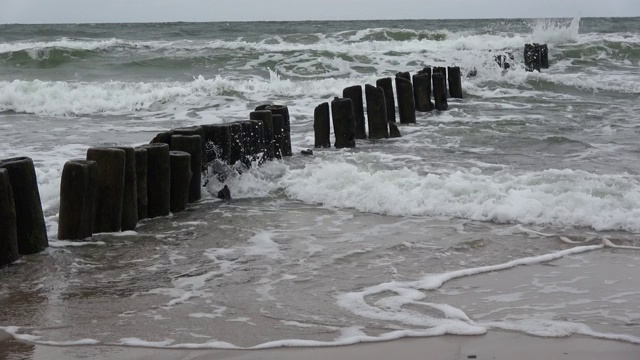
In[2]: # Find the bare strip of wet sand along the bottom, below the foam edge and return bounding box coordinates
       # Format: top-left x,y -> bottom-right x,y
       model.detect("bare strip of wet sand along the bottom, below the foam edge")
0,332 -> 640,360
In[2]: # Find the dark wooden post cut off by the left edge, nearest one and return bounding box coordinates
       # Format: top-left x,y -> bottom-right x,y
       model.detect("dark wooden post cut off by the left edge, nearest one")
0,168 -> 20,268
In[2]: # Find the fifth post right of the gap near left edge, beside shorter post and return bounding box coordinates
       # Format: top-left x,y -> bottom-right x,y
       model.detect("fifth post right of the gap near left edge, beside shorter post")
142,143 -> 171,218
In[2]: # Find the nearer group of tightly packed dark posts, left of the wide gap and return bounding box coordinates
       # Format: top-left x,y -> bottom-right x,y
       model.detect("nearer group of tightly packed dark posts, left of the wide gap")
0,104 -> 292,267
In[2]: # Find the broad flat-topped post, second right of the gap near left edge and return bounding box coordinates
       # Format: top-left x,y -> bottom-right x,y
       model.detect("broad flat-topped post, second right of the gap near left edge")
87,145 -> 126,233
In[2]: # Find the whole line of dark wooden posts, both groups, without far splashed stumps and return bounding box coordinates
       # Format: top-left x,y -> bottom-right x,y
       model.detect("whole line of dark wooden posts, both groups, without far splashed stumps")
0,67 -> 470,267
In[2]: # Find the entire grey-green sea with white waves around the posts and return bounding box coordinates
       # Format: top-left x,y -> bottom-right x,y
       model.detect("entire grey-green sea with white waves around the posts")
0,18 -> 640,358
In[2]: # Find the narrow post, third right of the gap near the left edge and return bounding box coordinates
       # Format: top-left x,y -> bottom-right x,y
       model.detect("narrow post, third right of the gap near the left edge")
116,146 -> 138,231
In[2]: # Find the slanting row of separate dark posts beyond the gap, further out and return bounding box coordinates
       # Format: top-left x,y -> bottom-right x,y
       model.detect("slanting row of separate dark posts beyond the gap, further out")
313,66 -> 462,148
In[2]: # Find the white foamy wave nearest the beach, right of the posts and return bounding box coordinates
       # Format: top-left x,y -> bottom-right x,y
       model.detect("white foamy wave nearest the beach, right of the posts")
281,159 -> 640,232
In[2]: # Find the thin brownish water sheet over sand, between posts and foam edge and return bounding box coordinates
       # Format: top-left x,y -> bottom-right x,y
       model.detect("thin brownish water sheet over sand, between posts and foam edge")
0,200 -> 640,360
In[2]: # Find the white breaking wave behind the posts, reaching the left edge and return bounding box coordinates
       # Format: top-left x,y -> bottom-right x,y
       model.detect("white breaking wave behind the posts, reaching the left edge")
0,72 -> 364,116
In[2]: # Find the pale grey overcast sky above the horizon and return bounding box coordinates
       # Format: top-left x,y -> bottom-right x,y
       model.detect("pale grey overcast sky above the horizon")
0,0 -> 640,23
